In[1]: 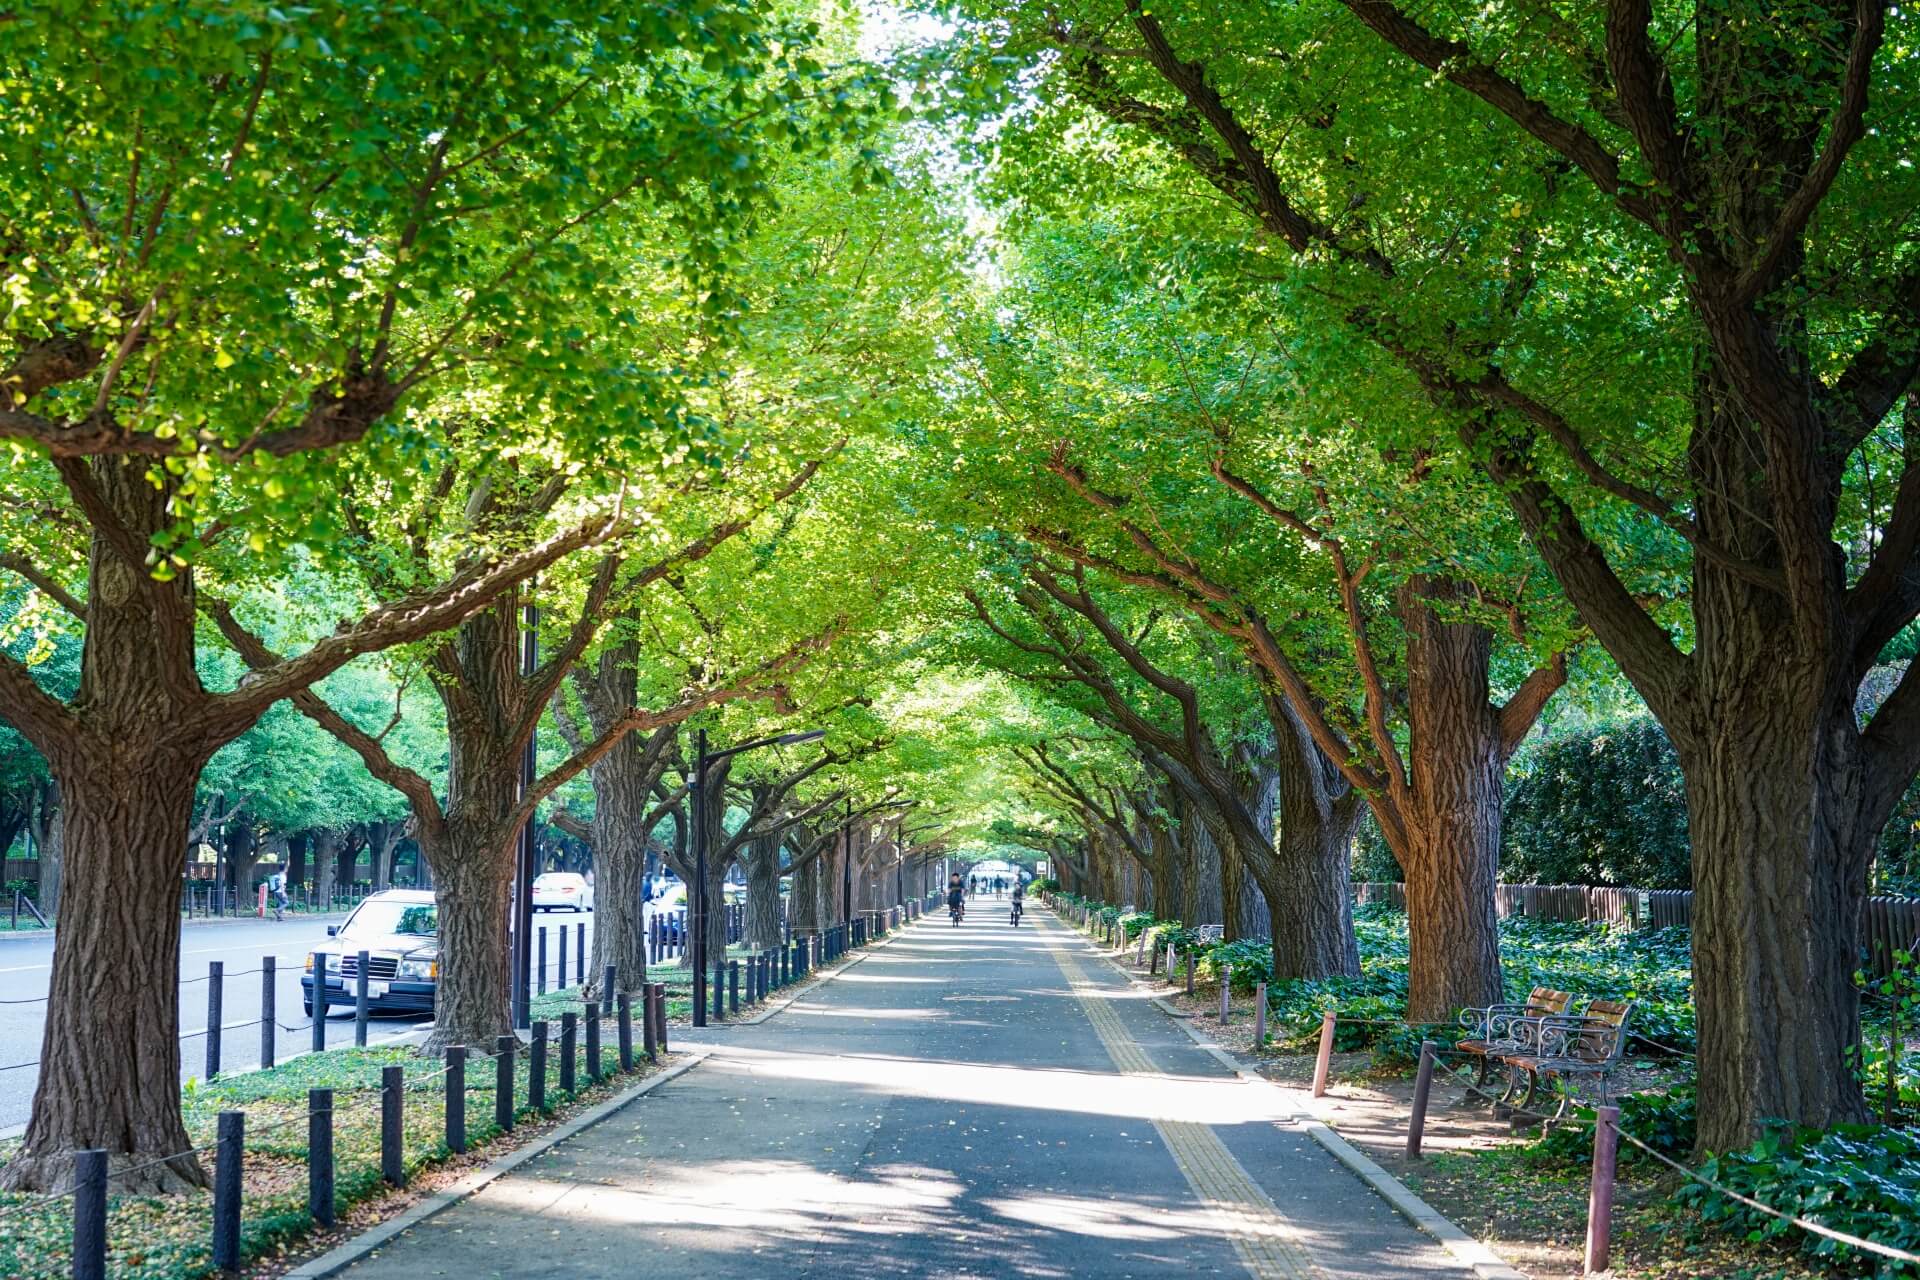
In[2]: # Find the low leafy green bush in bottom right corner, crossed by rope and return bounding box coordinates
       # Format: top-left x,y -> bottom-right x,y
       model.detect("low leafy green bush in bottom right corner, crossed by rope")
1674,1125 -> 1920,1276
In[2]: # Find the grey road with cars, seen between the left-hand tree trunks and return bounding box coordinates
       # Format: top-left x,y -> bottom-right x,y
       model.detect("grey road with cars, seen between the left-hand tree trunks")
0,912 -> 593,1134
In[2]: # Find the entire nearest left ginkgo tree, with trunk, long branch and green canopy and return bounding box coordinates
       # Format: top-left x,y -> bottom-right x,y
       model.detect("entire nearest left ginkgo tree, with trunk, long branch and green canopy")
0,0 -> 891,1190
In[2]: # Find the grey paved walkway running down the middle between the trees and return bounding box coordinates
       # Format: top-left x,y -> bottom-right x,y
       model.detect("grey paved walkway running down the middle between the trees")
344,900 -> 1471,1280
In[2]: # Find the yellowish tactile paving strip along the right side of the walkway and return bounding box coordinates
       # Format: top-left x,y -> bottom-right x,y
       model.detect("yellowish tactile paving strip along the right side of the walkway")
1046,931 -> 1323,1280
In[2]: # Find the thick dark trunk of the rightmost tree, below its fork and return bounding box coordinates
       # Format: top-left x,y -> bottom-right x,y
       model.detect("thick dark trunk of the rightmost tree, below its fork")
1674,667 -> 1876,1150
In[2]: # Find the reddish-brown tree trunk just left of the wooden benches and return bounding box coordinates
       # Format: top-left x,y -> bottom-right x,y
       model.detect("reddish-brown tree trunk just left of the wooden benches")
1396,578 -> 1507,1023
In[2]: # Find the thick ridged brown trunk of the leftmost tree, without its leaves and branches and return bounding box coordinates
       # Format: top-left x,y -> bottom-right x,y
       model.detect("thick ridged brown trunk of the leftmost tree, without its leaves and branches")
0,462 -> 221,1192
